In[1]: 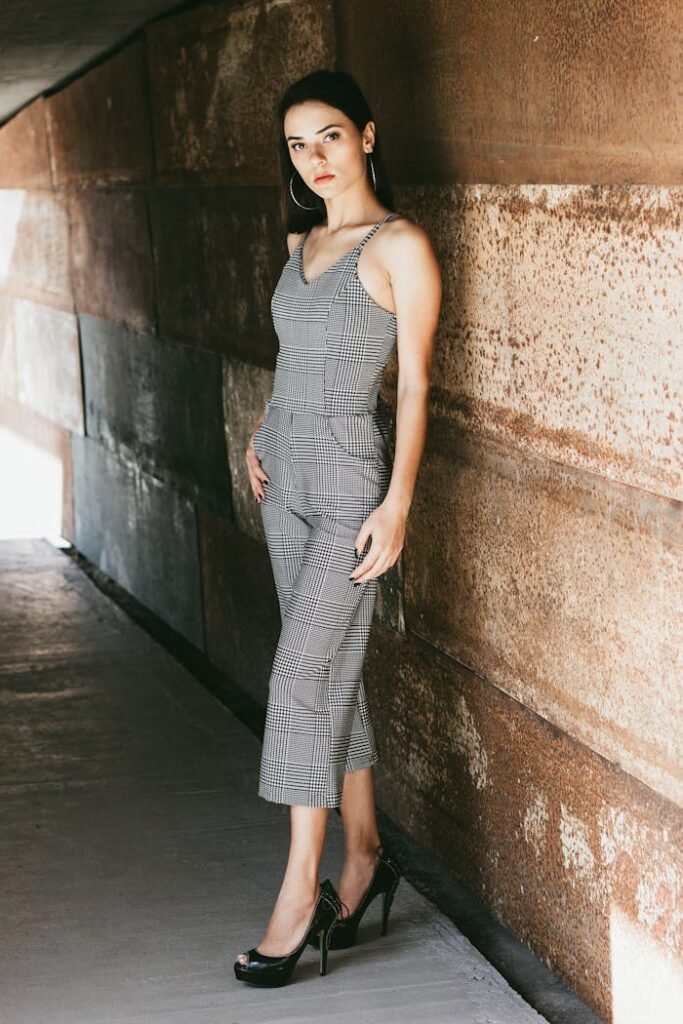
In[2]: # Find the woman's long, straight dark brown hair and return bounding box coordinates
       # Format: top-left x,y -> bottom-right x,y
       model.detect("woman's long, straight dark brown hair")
278,69 -> 394,233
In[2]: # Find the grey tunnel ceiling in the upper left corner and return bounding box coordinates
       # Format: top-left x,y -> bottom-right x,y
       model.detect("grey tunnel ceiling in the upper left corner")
0,0 -> 181,123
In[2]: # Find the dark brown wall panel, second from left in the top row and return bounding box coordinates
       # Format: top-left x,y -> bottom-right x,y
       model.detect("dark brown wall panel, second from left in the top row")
46,39 -> 152,187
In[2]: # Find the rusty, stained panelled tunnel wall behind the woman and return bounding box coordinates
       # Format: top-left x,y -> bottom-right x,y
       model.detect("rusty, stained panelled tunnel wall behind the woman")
0,0 -> 683,1024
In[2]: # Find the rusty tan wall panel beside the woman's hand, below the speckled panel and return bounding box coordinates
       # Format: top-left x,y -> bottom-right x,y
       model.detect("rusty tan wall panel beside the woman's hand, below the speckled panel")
405,409 -> 683,803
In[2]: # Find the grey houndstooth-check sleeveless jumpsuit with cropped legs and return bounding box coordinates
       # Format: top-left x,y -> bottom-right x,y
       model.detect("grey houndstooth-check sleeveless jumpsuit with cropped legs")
254,213 -> 399,807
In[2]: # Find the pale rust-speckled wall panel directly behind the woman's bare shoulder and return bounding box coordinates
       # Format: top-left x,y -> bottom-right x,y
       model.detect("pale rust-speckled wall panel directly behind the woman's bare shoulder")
401,185 -> 683,501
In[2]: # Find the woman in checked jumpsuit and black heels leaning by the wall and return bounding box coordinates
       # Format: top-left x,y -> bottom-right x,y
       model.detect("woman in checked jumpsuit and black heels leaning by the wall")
234,71 -> 441,985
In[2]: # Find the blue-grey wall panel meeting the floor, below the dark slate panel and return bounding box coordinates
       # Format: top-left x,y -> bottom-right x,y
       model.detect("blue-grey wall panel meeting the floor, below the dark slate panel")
72,435 -> 204,648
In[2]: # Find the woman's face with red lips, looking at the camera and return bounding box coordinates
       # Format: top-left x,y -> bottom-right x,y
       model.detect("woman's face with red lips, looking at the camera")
285,100 -> 374,199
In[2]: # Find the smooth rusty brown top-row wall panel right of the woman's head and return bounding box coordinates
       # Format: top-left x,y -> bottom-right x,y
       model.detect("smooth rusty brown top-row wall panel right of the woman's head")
337,0 -> 683,184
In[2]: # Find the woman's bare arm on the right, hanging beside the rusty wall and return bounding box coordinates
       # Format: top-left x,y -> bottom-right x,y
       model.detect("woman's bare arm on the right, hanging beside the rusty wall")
349,221 -> 442,583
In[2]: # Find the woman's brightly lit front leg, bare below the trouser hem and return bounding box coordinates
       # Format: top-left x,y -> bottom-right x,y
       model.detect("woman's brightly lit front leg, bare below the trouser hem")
237,807 -> 330,964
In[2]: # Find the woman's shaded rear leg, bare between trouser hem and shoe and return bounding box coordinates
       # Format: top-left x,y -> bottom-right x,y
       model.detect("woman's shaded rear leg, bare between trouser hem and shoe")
337,768 -> 380,916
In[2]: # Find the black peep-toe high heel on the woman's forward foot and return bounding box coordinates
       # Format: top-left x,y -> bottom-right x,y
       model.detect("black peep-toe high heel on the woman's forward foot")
234,879 -> 341,988
